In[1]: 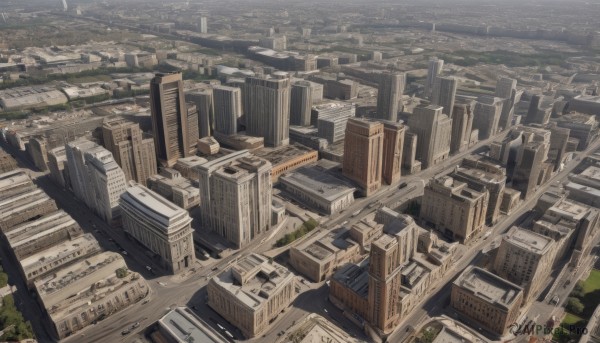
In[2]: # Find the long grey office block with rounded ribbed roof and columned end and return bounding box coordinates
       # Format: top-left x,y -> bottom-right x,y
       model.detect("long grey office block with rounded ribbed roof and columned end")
120,185 -> 195,274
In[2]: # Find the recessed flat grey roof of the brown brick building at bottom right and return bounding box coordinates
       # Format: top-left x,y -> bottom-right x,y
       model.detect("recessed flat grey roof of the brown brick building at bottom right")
453,266 -> 523,308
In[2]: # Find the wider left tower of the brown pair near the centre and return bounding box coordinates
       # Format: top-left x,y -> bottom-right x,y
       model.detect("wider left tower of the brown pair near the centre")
342,118 -> 383,196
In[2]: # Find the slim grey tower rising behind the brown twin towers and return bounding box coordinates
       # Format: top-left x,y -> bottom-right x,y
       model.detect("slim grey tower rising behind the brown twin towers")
377,73 -> 406,121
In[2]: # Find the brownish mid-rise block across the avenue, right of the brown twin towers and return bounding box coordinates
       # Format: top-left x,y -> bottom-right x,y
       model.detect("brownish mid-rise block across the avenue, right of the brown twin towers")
420,176 -> 489,244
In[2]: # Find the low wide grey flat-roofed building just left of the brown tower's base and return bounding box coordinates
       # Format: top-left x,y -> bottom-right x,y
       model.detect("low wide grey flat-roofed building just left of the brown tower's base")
280,167 -> 355,215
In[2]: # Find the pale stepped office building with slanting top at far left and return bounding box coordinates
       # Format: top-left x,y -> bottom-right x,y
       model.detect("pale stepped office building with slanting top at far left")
65,139 -> 127,223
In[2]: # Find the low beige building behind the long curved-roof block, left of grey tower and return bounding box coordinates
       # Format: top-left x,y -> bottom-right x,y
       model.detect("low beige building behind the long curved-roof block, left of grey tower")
148,168 -> 200,210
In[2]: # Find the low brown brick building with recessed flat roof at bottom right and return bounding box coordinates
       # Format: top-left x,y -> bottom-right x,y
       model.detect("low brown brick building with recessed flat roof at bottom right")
450,266 -> 523,336
